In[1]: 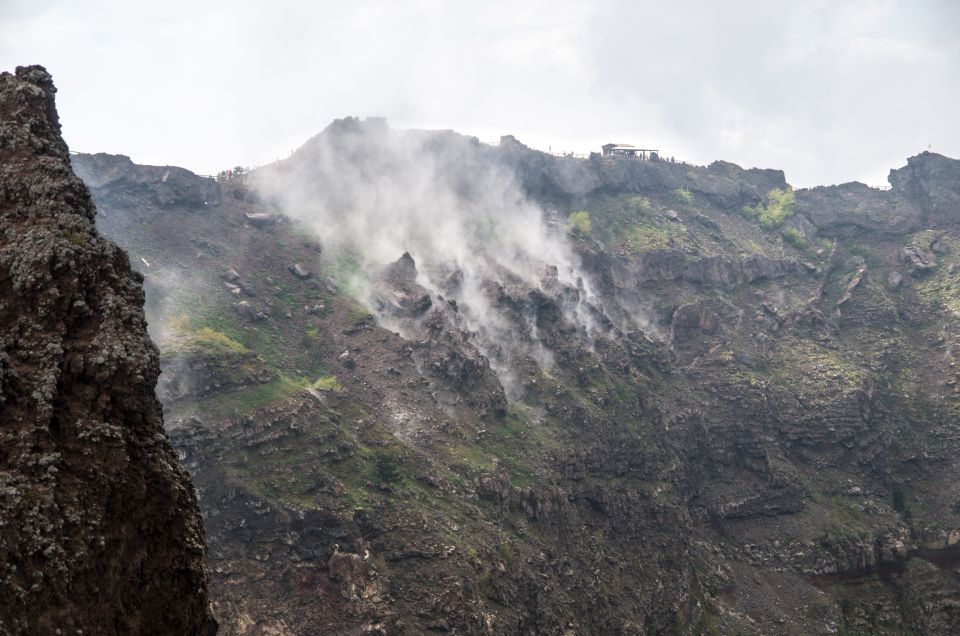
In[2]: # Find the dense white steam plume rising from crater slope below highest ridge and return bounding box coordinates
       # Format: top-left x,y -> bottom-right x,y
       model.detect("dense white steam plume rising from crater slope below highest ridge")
256,119 -> 606,391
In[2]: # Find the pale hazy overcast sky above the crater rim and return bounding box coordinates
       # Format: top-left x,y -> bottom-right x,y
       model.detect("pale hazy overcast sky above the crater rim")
0,0 -> 960,186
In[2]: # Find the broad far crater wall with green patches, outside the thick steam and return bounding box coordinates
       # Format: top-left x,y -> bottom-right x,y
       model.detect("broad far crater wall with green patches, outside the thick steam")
74,120 -> 960,635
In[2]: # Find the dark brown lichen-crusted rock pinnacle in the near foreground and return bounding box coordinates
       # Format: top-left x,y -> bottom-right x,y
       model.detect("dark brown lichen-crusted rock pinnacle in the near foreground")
0,66 -> 216,634
